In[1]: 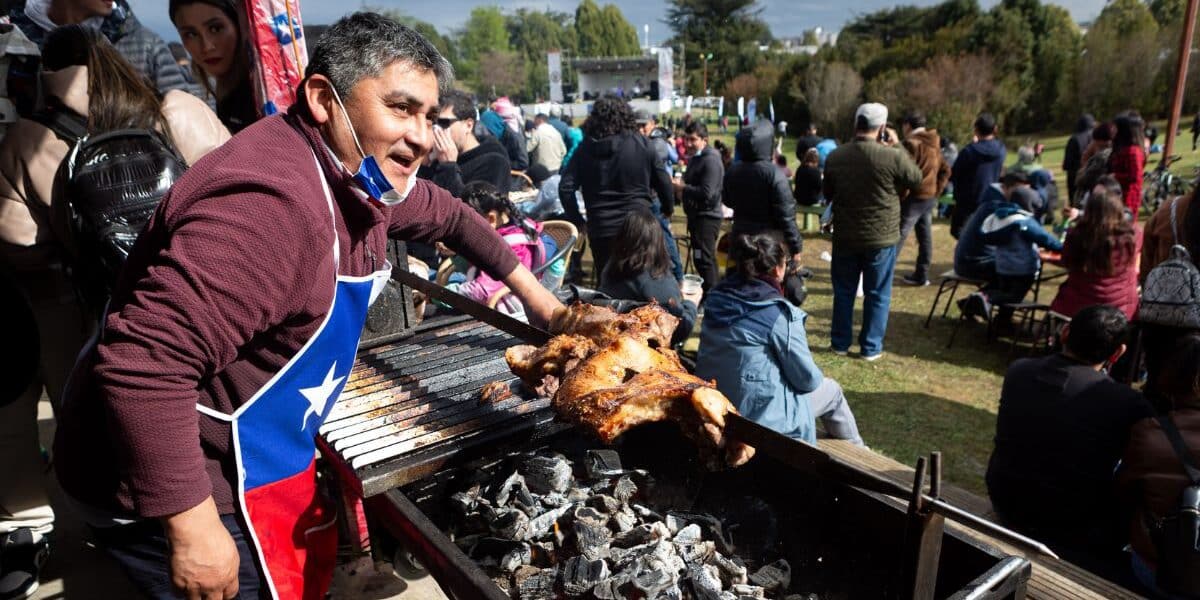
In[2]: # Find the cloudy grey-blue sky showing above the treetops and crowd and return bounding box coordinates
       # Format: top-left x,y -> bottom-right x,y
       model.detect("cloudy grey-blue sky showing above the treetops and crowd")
130,0 -> 1105,44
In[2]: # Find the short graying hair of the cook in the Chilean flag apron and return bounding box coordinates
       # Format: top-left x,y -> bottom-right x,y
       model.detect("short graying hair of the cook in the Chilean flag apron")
305,12 -> 454,98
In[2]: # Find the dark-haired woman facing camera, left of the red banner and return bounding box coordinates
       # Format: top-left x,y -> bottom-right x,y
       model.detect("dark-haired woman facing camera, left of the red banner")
168,0 -> 258,133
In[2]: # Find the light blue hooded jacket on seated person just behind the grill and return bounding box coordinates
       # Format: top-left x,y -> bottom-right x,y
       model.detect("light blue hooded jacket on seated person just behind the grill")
696,275 -> 824,444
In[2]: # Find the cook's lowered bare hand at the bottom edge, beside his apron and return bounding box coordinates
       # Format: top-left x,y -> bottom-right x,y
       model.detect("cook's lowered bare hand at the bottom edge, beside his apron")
162,496 -> 241,600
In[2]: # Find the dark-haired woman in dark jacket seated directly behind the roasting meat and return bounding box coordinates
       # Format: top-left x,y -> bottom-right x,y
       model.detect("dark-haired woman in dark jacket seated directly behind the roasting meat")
600,206 -> 701,344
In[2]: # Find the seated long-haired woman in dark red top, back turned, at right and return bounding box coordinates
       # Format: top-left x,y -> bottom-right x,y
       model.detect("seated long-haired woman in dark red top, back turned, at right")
1050,175 -> 1141,319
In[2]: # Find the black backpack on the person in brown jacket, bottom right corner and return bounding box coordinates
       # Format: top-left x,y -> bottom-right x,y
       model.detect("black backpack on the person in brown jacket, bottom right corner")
1147,415 -> 1200,598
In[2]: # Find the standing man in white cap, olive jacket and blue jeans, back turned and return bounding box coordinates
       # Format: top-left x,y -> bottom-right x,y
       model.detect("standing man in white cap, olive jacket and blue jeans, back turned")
824,102 -> 922,360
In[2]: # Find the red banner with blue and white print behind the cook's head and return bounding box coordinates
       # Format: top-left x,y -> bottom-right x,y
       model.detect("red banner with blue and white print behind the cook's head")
242,0 -> 308,116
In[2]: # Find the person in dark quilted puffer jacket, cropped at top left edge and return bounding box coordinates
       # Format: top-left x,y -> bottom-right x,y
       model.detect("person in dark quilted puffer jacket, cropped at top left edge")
10,0 -> 204,98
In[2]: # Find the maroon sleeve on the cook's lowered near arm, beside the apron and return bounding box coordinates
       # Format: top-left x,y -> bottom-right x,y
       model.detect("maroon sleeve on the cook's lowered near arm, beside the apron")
94,188 -> 332,517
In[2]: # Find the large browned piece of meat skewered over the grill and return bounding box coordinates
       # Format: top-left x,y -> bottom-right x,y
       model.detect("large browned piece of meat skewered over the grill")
505,304 -> 754,466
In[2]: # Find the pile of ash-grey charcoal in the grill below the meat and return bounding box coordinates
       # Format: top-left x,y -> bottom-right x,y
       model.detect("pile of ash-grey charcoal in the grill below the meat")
451,450 -> 796,600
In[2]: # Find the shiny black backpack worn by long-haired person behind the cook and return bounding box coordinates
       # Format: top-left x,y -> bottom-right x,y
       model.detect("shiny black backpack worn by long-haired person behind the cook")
35,109 -> 187,305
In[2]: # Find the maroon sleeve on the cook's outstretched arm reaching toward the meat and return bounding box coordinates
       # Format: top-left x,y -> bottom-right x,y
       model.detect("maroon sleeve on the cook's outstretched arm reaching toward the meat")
388,181 -> 518,281
